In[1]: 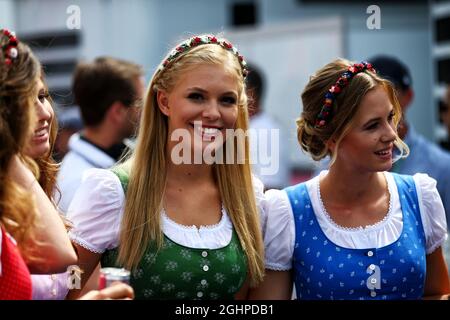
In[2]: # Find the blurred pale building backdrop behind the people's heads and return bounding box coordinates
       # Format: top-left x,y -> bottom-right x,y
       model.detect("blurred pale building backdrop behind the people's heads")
0,0 -> 450,181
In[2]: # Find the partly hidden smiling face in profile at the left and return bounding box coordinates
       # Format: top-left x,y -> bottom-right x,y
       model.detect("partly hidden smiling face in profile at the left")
26,79 -> 55,159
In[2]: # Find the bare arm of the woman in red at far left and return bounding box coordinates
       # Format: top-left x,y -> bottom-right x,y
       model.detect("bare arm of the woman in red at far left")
8,156 -> 77,273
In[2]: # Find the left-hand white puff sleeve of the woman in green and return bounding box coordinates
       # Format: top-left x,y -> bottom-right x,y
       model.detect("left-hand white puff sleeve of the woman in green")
67,169 -> 125,253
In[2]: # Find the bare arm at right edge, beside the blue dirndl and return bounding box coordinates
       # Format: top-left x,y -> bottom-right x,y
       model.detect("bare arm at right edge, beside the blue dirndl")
424,248 -> 450,299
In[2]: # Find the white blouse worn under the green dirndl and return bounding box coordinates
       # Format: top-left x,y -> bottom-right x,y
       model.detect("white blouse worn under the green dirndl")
67,169 -> 264,253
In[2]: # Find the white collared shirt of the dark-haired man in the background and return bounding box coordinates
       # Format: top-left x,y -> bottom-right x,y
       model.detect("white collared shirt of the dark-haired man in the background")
57,133 -> 116,214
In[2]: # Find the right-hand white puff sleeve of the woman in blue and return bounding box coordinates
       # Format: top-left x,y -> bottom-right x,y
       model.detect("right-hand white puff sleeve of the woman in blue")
414,173 -> 447,254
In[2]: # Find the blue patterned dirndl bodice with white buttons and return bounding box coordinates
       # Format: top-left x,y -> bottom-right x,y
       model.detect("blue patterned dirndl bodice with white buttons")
285,174 -> 426,300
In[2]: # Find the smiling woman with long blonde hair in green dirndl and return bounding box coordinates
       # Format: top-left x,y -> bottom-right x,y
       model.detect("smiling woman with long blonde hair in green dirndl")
68,35 -> 264,299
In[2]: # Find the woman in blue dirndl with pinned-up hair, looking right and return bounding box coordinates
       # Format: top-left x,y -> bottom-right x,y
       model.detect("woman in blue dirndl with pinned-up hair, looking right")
251,59 -> 450,300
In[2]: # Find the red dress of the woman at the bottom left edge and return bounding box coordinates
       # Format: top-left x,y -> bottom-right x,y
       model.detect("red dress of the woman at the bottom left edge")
0,228 -> 31,300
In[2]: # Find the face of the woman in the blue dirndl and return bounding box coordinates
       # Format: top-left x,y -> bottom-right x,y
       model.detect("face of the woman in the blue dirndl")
335,86 -> 396,172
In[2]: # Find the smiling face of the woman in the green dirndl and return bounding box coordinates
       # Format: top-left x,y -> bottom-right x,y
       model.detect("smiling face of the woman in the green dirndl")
157,64 -> 243,156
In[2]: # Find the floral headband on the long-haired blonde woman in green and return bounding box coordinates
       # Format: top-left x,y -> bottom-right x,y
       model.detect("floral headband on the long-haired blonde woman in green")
158,35 -> 248,78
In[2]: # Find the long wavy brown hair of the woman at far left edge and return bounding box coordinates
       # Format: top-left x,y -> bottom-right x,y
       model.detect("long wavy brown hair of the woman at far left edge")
0,33 -> 41,260
